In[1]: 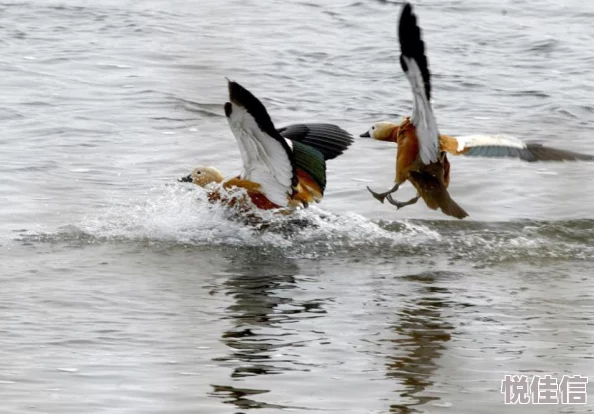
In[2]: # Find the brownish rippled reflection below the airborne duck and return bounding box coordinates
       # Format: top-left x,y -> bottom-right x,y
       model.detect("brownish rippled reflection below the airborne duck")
387,272 -> 453,414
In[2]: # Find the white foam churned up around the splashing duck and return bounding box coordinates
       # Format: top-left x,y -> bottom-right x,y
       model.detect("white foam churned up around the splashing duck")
76,184 -> 439,251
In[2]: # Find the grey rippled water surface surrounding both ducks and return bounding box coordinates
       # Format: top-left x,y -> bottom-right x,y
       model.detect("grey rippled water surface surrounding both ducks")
0,0 -> 594,414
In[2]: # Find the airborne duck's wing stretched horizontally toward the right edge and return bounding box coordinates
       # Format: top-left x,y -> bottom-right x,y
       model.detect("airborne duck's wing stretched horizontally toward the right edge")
440,135 -> 594,162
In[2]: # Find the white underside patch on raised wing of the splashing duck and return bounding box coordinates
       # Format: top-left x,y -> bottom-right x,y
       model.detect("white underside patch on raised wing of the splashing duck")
227,103 -> 293,207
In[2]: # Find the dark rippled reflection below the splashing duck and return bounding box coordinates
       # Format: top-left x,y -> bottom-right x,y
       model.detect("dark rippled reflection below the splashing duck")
211,250 -> 325,409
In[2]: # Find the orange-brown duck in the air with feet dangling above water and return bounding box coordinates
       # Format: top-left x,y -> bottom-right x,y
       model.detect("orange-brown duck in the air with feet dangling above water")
360,3 -> 594,219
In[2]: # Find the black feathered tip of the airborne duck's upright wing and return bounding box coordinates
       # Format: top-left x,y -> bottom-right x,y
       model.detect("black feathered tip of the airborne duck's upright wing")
398,3 -> 431,101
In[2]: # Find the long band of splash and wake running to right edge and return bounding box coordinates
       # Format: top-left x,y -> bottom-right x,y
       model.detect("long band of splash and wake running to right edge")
10,184 -> 594,266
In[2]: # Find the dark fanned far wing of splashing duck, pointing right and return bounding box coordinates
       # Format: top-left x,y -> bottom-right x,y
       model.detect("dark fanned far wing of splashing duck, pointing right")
278,123 -> 353,160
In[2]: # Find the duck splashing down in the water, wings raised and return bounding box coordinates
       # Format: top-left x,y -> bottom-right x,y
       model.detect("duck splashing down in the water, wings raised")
179,81 -> 353,210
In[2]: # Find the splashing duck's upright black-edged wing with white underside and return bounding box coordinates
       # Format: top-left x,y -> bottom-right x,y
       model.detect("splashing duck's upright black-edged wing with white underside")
225,81 -> 297,207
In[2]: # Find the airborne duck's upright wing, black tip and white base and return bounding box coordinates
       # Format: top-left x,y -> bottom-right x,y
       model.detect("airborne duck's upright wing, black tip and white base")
398,3 -> 439,164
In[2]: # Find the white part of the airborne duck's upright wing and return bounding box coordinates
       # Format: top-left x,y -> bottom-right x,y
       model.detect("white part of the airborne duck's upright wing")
402,56 -> 439,164
